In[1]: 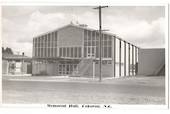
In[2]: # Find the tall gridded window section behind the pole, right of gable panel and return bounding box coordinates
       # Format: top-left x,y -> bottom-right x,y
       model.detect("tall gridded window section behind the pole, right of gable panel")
84,30 -> 112,58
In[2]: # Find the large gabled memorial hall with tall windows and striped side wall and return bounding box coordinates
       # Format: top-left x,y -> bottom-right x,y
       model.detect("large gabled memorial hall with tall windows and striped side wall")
32,24 -> 138,78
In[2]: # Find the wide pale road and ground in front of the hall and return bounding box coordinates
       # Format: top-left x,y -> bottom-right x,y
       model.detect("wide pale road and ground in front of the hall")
2,77 -> 165,104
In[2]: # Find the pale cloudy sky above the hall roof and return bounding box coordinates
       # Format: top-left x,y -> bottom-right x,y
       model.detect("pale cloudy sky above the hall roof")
2,6 -> 165,56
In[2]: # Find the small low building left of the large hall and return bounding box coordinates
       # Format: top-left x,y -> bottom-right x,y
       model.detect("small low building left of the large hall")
2,54 -> 32,75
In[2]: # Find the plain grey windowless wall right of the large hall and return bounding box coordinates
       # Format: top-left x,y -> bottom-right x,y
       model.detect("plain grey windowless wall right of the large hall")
138,49 -> 165,75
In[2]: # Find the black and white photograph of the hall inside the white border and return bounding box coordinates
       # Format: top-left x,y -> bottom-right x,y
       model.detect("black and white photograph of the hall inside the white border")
1,5 -> 167,108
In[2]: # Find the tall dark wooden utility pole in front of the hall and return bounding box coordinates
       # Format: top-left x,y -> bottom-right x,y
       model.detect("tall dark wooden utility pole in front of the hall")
93,6 -> 108,82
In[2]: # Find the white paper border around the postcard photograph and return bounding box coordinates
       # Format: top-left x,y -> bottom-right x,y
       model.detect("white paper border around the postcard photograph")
0,0 -> 169,109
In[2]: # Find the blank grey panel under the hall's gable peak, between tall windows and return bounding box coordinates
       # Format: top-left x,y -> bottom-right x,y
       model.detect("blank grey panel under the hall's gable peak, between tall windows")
57,26 -> 84,47
